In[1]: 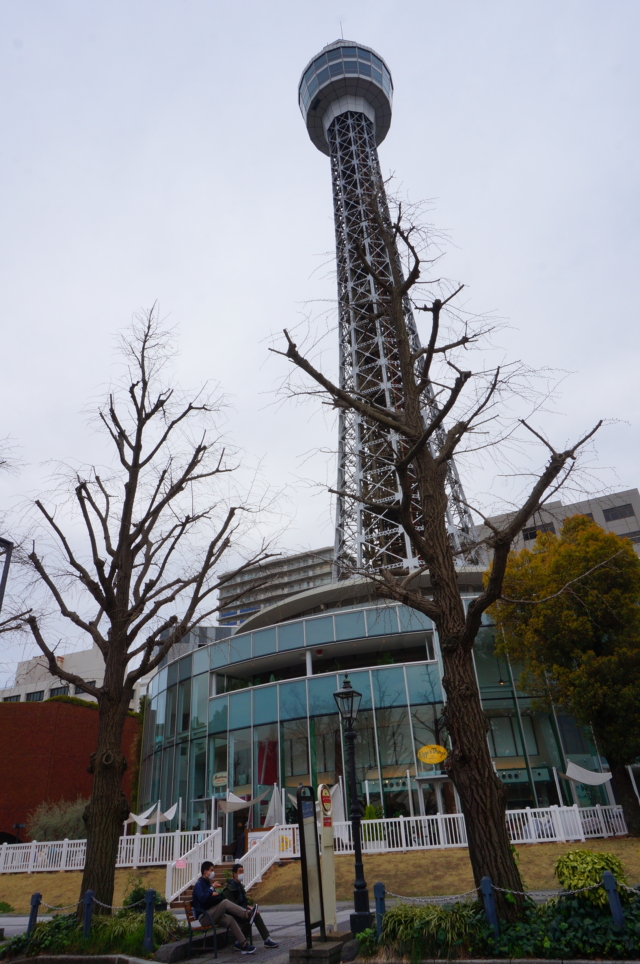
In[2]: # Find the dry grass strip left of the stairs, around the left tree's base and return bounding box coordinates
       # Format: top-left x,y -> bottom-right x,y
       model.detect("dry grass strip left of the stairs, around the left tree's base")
0,867 -> 167,926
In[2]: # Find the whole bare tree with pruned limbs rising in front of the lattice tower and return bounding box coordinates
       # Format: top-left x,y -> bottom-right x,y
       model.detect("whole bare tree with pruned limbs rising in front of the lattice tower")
272,186 -> 599,917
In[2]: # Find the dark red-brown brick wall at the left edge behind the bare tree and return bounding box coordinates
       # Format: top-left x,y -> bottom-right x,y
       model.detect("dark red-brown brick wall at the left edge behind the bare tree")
0,702 -> 138,840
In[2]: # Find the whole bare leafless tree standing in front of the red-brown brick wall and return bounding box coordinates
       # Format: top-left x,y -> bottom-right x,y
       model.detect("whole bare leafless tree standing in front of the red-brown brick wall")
15,309 -> 270,905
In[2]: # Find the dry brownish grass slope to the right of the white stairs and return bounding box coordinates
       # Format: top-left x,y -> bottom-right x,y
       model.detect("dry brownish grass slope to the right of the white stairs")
251,837 -> 640,904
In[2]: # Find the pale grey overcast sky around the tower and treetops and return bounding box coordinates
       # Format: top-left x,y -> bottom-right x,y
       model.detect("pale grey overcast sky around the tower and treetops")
0,0 -> 640,676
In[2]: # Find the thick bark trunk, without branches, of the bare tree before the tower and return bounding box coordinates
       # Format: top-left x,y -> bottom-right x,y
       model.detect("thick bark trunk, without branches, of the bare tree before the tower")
440,640 -> 524,919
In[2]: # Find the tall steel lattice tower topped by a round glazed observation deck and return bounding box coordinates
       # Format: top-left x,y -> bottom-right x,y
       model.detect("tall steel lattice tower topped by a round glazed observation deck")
299,40 -> 475,579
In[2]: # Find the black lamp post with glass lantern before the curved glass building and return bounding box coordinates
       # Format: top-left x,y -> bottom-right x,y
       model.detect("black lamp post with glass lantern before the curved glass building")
333,676 -> 373,934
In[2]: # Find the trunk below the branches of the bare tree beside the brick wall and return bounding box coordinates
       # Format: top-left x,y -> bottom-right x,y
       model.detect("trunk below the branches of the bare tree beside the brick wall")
80,699 -> 129,913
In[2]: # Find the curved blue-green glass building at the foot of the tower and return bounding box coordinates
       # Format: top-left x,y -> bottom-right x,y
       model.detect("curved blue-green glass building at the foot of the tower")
141,567 -> 609,841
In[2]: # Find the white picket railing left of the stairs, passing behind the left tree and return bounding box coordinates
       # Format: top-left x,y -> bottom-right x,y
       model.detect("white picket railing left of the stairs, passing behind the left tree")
0,830 -> 211,874
